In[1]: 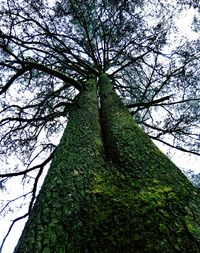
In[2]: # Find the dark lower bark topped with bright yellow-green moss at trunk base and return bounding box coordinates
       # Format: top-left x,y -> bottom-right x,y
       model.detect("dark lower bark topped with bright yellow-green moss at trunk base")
88,166 -> 199,253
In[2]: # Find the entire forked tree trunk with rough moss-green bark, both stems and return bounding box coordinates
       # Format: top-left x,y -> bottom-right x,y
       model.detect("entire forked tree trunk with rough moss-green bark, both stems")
15,74 -> 200,253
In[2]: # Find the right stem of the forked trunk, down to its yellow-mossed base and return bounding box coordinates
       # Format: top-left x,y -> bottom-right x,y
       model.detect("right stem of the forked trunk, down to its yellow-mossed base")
99,75 -> 200,253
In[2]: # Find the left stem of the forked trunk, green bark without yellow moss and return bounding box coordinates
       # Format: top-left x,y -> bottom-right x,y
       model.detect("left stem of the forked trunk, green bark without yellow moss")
15,80 -> 102,253
